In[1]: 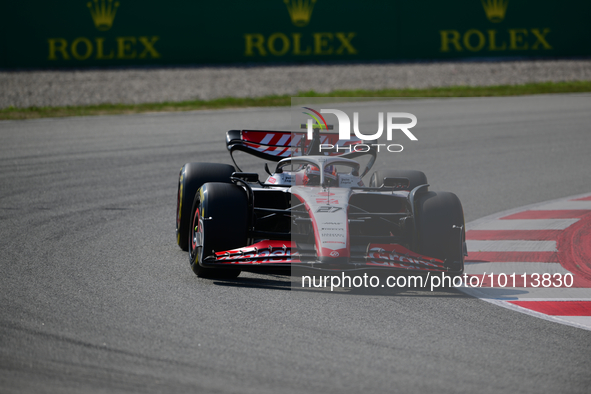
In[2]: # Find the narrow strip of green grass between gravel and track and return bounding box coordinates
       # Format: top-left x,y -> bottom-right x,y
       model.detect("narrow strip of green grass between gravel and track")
0,81 -> 591,120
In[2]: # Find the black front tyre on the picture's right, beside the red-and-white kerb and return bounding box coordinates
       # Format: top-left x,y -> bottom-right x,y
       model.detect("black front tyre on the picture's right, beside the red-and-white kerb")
415,192 -> 466,275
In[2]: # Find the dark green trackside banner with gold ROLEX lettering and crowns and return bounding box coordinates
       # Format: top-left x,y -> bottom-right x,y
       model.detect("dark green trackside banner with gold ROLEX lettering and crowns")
0,0 -> 591,68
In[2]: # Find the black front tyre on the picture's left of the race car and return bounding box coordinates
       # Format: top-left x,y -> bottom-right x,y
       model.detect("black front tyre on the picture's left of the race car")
189,183 -> 248,278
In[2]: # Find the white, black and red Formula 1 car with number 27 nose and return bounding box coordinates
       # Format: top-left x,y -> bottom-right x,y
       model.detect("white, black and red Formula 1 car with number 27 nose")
176,129 -> 466,278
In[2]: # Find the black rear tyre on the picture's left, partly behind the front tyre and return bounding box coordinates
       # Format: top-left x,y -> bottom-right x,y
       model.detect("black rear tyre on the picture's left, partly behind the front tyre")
176,163 -> 236,251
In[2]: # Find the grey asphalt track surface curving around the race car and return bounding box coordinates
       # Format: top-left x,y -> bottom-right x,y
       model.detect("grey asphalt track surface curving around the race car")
0,95 -> 591,393
